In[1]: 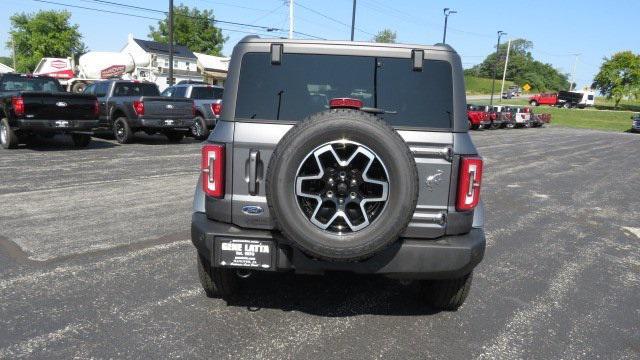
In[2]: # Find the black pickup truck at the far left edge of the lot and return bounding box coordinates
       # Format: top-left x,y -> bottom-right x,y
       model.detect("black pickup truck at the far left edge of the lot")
0,73 -> 98,149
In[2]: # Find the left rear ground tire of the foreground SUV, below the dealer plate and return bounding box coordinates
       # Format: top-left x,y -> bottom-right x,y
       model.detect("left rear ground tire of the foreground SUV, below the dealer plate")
198,254 -> 240,298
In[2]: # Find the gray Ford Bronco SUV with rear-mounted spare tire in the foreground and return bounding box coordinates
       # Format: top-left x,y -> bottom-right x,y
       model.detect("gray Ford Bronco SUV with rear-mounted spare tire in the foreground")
191,36 -> 485,310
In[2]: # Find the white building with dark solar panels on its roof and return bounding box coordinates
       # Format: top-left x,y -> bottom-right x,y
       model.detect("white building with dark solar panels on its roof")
121,35 -> 204,91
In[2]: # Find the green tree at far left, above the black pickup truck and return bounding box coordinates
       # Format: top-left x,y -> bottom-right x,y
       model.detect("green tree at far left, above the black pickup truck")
6,10 -> 87,72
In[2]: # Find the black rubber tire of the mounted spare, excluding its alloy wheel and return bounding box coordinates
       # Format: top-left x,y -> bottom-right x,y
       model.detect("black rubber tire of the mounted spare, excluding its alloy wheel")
267,110 -> 418,261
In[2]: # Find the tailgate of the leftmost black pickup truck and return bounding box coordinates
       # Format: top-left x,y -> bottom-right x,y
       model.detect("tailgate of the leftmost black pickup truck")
20,92 -> 96,120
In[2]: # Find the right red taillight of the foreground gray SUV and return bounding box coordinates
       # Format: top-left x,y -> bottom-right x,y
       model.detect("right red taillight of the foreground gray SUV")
456,156 -> 482,211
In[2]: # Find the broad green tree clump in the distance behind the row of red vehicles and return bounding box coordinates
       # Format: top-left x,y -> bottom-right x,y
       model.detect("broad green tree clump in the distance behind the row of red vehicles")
465,39 -> 569,91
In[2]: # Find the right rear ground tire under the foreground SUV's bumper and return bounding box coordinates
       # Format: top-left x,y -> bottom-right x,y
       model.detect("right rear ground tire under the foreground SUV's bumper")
422,273 -> 473,311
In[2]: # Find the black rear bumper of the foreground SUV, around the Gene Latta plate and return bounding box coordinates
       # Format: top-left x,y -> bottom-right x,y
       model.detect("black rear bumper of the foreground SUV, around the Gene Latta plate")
191,213 -> 485,279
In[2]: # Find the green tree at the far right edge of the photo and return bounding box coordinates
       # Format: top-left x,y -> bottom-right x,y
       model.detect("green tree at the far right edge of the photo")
591,51 -> 640,107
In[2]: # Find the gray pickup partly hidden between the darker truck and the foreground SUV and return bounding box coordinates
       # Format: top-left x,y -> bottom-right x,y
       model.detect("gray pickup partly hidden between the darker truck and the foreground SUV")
162,81 -> 224,140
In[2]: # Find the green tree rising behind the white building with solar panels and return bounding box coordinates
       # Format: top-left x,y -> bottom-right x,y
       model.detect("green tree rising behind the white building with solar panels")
148,4 -> 228,55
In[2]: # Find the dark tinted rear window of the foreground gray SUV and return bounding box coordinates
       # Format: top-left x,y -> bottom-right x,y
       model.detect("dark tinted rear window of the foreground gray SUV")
236,53 -> 453,129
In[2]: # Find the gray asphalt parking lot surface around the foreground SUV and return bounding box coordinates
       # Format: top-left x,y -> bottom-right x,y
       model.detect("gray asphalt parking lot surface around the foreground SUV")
0,128 -> 640,359
